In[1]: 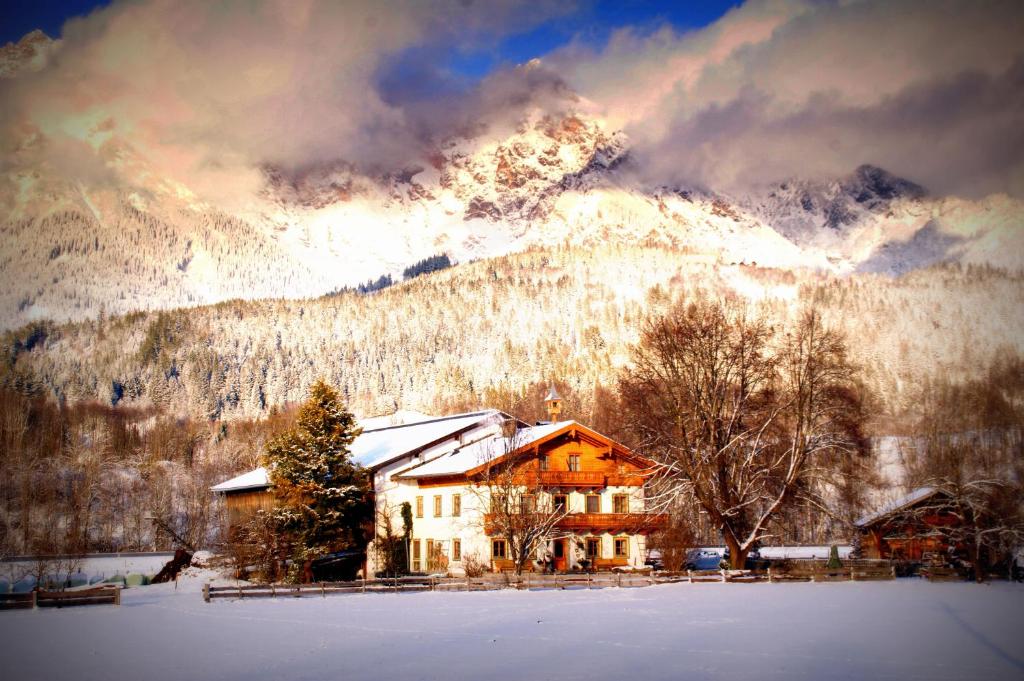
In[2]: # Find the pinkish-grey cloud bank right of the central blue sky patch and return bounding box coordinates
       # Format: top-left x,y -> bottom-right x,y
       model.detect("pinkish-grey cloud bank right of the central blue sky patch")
548,0 -> 1024,196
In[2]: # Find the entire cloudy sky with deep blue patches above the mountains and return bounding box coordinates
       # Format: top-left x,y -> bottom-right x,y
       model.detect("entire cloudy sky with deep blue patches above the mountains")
0,0 -> 1024,203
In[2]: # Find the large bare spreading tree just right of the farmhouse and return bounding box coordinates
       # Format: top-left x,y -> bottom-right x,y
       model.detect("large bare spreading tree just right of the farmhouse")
620,300 -> 866,567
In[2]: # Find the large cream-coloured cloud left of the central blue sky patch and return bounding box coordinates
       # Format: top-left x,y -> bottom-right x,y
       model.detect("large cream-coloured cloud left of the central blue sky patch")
0,0 -> 571,205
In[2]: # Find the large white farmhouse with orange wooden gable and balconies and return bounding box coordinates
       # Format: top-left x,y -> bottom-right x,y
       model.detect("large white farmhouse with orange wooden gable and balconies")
213,391 -> 667,574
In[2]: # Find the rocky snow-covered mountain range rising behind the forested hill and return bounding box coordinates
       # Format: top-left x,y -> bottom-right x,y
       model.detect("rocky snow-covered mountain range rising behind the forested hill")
0,32 -> 1024,328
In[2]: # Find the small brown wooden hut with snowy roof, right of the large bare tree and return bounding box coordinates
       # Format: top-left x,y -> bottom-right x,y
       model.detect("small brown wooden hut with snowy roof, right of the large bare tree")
854,487 -> 953,561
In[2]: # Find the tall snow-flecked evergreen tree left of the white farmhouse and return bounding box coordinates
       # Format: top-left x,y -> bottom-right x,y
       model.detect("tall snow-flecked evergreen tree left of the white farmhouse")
266,380 -> 373,581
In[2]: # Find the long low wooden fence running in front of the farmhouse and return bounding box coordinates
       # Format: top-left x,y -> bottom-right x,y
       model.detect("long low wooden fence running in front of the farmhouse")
203,563 -> 895,602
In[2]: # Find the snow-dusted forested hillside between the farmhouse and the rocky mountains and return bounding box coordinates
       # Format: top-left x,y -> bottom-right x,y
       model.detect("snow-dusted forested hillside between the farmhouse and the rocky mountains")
0,246 -> 1024,419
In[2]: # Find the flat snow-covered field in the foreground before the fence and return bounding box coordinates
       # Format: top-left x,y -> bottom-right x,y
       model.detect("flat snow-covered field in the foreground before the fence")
0,568 -> 1024,681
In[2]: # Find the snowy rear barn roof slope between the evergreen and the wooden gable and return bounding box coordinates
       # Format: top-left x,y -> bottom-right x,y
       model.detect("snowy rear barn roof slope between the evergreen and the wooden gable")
350,410 -> 501,468
